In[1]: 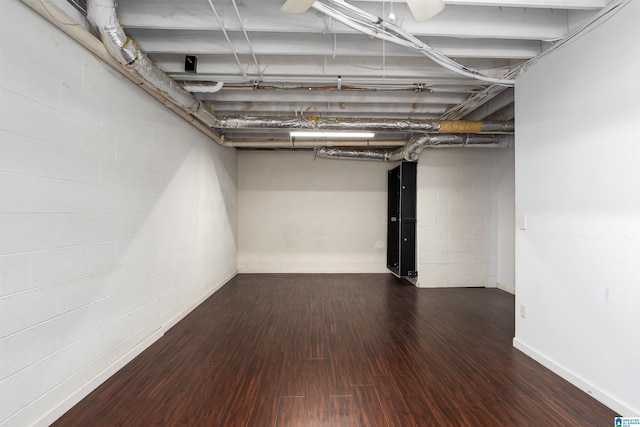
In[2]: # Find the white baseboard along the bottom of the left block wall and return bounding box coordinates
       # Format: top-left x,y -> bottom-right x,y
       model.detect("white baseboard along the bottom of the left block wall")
34,271 -> 238,427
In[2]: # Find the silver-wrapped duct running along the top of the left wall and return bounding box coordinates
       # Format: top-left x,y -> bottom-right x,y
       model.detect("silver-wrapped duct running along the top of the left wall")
87,0 -> 224,144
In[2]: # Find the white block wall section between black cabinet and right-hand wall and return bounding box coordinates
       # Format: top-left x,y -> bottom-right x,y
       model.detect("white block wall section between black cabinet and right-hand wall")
417,149 -> 513,287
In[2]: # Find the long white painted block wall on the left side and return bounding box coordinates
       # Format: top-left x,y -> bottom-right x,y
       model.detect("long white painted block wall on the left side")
0,0 -> 237,426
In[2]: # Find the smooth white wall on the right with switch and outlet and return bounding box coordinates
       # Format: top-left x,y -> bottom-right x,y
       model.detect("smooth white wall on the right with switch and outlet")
514,1 -> 640,416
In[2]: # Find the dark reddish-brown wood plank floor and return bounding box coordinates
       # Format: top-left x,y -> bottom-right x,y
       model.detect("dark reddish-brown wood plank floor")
54,274 -> 615,427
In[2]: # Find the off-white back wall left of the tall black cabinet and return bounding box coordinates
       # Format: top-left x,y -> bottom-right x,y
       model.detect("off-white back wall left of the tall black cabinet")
238,151 -> 393,273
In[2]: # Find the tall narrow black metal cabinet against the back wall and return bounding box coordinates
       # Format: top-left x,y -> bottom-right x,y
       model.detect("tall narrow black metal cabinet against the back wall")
387,162 -> 418,277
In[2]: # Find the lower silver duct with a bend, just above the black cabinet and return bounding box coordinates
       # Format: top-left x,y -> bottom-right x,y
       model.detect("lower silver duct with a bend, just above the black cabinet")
315,134 -> 513,162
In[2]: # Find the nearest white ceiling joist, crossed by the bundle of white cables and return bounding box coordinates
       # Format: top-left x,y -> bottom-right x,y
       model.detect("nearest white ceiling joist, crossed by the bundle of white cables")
119,0 -> 568,40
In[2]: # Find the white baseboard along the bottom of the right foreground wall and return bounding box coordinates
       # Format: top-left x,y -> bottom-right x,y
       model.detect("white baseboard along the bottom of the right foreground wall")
513,338 -> 640,417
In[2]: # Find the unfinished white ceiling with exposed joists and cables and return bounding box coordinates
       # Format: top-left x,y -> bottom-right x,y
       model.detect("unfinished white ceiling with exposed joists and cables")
65,0 -> 615,149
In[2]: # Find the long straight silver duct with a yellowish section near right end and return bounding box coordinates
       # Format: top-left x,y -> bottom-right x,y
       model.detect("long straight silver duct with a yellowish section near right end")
218,116 -> 514,133
